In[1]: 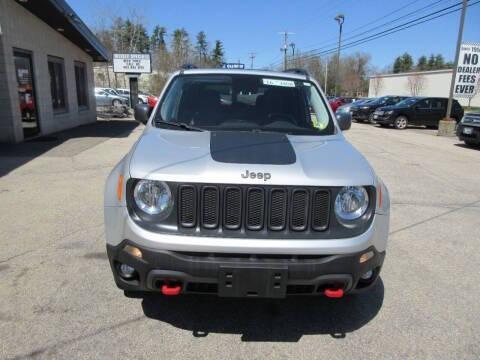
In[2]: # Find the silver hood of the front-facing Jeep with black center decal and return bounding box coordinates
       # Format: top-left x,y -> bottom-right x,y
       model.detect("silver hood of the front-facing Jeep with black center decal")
130,127 -> 375,186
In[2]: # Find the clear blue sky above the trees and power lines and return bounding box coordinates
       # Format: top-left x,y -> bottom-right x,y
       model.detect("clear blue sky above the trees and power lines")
67,0 -> 480,69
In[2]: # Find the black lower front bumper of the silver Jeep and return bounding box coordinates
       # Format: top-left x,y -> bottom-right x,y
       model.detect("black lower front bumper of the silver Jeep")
107,240 -> 385,298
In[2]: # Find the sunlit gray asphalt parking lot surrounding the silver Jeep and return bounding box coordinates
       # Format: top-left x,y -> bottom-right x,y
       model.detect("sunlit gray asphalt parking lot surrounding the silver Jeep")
0,120 -> 480,359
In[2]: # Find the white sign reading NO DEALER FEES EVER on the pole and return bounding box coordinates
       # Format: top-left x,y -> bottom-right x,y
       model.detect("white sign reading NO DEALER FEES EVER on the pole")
453,43 -> 480,98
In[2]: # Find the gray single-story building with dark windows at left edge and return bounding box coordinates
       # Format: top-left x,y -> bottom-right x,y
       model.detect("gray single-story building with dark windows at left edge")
0,0 -> 108,142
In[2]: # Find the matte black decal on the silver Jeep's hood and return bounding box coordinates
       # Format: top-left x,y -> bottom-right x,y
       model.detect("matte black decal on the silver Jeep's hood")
210,131 -> 297,165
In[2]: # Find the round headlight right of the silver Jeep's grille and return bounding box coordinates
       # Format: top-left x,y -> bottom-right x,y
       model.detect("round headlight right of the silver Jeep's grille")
335,186 -> 369,226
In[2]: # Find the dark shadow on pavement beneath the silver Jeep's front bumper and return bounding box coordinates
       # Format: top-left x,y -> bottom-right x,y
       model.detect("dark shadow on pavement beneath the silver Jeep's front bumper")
142,278 -> 384,342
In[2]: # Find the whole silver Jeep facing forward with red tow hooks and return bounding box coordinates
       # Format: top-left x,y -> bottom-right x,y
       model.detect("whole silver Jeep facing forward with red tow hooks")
105,69 -> 390,298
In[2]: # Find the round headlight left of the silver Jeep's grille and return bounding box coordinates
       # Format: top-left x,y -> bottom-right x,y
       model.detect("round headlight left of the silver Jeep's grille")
133,180 -> 173,219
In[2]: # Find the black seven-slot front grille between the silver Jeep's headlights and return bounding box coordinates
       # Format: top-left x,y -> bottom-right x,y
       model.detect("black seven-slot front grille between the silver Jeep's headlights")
177,184 -> 331,233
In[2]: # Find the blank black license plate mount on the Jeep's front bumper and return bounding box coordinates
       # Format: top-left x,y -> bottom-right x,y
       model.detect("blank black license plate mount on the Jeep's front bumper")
218,266 -> 288,298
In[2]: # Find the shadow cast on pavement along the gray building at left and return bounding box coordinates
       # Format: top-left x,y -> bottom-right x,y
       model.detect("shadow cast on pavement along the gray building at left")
0,119 -> 138,177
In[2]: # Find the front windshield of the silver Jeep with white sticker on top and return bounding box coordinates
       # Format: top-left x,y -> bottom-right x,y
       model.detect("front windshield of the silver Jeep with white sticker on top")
154,74 -> 335,135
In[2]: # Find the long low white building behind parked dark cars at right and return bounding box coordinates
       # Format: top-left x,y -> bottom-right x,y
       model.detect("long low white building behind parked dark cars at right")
368,69 -> 480,107
